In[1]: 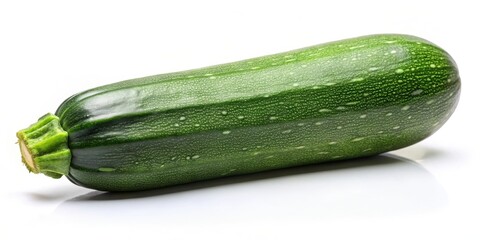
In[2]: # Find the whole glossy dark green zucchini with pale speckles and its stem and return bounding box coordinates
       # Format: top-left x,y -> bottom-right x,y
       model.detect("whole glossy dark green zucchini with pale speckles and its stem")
17,34 -> 460,191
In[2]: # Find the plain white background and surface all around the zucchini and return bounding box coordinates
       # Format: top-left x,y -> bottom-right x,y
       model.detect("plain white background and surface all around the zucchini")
0,0 -> 480,239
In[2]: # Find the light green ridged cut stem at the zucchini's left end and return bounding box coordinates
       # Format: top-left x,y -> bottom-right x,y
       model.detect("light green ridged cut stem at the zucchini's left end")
17,113 -> 72,178
